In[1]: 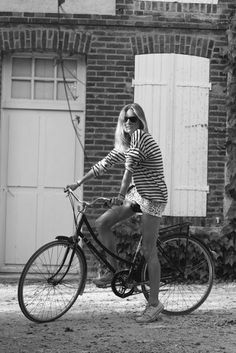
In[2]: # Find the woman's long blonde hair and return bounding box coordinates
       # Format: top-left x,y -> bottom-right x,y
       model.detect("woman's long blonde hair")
115,103 -> 148,152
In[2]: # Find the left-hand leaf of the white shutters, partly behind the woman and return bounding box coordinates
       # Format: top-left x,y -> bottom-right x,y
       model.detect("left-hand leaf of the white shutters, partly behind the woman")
134,54 -> 173,214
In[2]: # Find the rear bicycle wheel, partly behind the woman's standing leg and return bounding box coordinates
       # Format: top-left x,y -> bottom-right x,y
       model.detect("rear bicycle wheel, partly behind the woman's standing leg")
141,234 -> 214,315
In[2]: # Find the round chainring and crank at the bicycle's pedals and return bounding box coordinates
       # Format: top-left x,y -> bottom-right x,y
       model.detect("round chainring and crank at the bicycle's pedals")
111,270 -> 135,298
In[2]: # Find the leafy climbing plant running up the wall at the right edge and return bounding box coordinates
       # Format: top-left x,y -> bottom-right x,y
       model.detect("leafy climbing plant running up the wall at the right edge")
209,12 -> 236,279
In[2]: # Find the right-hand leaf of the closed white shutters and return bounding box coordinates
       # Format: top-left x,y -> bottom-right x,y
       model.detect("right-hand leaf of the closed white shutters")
172,55 -> 210,216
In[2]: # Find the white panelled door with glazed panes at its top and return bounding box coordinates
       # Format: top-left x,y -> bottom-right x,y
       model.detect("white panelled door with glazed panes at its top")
0,56 -> 85,270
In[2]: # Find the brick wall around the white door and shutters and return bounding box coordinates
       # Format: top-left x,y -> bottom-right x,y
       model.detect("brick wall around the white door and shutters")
0,0 -> 235,270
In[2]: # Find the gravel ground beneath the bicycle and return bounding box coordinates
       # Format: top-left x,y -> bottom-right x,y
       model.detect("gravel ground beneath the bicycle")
0,279 -> 236,353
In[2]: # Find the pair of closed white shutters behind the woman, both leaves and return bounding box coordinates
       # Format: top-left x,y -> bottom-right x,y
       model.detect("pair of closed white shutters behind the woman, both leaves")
134,54 -> 210,217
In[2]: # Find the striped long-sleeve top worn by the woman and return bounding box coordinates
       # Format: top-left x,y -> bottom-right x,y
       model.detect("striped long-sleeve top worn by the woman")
92,129 -> 167,203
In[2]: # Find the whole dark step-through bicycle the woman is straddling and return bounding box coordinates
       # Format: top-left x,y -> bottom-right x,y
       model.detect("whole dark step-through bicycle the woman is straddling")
18,189 -> 214,323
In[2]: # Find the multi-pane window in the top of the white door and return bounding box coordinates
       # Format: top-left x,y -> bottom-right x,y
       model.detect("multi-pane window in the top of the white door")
11,57 -> 78,100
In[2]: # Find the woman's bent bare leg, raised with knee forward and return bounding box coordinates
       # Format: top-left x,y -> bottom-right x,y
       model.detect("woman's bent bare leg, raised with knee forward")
95,202 -> 134,269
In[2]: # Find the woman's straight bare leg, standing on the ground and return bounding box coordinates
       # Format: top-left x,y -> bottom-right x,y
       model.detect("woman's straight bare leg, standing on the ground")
142,213 -> 161,306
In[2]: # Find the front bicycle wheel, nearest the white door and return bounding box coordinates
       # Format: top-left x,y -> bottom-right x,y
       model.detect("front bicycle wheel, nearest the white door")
18,240 -> 87,323
